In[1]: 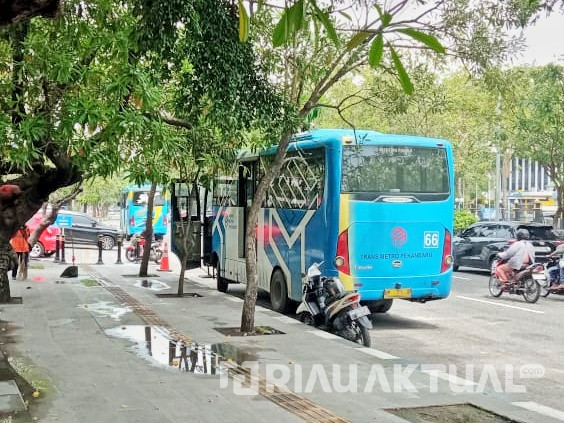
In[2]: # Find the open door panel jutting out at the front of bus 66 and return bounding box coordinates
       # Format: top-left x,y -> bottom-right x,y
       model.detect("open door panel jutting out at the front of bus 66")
171,182 -> 202,269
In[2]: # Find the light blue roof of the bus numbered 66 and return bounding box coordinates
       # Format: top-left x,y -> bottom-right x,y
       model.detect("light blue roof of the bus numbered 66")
238,129 -> 450,159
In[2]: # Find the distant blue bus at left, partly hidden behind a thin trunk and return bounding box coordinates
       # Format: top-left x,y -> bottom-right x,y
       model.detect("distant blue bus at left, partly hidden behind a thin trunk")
120,185 -> 170,240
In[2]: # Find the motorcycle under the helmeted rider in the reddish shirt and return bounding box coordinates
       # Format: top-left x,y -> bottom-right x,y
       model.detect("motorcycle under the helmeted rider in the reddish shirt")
489,260 -> 540,303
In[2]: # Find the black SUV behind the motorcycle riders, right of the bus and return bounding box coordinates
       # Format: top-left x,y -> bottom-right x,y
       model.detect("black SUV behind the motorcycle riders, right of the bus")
453,222 -> 562,270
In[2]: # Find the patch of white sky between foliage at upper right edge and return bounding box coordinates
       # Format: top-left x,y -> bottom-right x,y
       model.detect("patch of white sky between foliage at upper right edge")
515,11 -> 564,66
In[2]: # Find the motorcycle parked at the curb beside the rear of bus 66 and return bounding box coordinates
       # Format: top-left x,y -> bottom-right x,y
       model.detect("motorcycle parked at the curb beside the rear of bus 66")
296,263 -> 372,347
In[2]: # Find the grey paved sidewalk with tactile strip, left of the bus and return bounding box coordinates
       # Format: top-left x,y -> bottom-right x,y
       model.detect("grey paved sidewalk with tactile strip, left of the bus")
0,251 -> 548,423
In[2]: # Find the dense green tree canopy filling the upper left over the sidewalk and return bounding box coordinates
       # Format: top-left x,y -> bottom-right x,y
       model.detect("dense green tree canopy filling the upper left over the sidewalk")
0,0 -> 285,302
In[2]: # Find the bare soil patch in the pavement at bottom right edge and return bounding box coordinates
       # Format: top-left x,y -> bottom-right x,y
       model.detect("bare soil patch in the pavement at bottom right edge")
386,404 -> 518,423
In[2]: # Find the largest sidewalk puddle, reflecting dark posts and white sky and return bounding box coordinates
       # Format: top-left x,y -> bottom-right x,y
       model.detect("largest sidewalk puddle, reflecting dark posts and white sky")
105,325 -> 259,375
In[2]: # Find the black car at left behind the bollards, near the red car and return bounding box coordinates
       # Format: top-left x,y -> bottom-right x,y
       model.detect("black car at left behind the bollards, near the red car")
58,210 -> 121,250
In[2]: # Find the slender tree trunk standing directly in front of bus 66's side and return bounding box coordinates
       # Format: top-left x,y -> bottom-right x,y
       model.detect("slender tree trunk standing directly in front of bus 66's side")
241,131 -> 291,333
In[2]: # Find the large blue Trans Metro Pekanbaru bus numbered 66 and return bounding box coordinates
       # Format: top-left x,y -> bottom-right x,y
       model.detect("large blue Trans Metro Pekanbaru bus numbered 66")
211,129 -> 454,312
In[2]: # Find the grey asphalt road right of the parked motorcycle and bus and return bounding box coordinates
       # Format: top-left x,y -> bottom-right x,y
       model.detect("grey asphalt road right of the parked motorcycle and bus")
221,268 -> 564,421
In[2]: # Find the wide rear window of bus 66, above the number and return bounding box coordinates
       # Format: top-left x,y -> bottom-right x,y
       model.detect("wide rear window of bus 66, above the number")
341,145 -> 449,201
